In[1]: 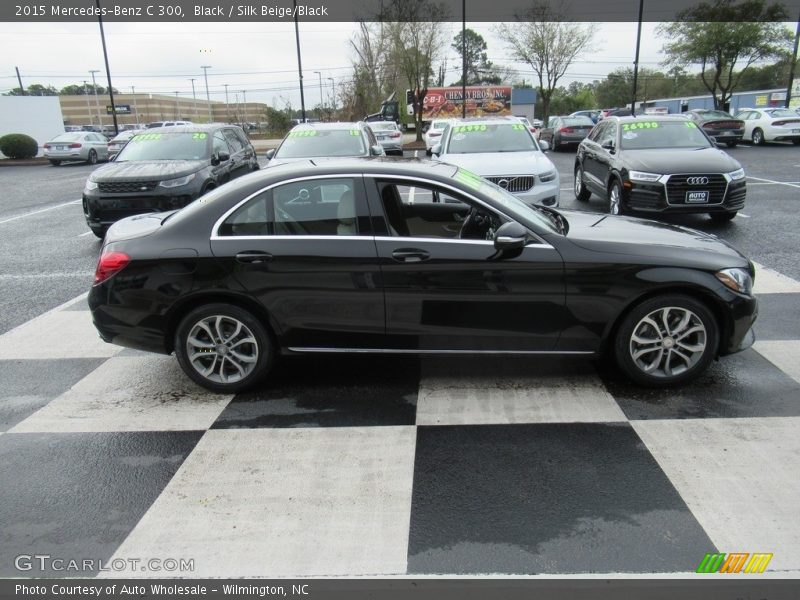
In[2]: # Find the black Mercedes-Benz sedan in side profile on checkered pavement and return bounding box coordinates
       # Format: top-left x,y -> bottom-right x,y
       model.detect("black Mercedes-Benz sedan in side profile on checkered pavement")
89,158 -> 757,392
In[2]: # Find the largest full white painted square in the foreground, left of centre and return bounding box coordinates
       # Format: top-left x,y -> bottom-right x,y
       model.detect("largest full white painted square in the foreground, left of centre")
102,427 -> 416,577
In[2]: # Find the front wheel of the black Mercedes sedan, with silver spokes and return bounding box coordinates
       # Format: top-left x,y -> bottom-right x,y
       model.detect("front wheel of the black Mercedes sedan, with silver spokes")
614,294 -> 719,387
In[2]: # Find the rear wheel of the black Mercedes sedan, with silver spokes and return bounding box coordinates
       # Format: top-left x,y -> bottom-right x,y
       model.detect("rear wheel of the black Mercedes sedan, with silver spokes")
174,303 -> 274,394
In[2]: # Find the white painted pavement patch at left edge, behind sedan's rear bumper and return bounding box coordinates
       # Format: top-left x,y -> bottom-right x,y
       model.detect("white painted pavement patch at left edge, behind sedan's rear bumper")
0,310 -> 122,360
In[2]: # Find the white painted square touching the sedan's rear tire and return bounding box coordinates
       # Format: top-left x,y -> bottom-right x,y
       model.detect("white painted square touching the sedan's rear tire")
11,355 -> 233,433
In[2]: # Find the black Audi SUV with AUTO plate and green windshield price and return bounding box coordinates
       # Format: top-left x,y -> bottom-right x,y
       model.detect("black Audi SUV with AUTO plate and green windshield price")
575,116 -> 747,221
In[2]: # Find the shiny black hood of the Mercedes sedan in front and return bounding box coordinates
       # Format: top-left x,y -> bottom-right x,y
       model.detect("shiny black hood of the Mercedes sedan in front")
559,210 -> 749,268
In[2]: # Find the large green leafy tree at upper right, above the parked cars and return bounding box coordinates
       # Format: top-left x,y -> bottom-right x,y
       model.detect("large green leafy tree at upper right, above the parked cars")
658,0 -> 792,109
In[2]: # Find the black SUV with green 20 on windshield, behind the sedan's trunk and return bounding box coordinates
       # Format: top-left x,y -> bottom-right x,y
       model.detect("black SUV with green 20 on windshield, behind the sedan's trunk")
83,125 -> 258,238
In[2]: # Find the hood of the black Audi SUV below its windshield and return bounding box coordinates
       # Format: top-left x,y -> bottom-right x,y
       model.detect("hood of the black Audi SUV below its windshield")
622,148 -> 742,174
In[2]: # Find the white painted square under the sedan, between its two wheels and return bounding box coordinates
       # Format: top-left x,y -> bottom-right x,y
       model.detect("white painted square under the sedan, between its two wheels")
417,357 -> 627,425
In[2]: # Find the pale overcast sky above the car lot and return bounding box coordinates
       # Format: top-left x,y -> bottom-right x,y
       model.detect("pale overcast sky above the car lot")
0,22 -> 680,110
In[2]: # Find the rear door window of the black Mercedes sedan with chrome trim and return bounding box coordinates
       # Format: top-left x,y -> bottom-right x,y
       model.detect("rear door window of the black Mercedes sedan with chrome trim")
218,178 -> 369,236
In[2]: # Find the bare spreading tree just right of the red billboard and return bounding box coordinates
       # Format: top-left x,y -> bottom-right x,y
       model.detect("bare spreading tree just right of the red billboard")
495,0 -> 596,120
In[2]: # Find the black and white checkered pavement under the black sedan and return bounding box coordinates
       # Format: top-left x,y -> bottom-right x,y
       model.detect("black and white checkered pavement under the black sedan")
0,266 -> 800,577
